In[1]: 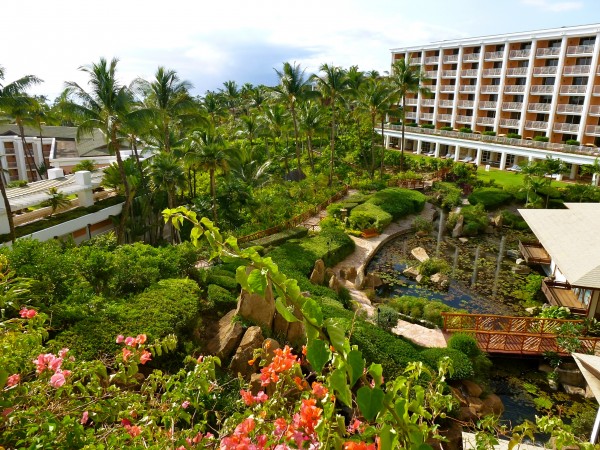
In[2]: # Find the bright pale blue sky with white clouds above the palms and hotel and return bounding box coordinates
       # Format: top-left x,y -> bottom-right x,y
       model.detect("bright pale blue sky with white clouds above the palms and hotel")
0,0 -> 600,99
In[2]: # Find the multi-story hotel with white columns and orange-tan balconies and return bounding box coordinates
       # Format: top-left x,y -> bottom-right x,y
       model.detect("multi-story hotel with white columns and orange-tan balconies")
385,24 -> 600,178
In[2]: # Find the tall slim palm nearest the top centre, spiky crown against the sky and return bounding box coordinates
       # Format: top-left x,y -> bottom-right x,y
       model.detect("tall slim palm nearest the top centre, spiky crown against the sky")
272,62 -> 310,172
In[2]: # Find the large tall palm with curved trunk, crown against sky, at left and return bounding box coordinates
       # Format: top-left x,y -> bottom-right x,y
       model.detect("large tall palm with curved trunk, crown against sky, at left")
66,58 -> 133,243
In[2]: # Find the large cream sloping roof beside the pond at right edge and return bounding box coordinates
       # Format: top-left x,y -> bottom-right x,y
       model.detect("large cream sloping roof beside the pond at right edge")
519,203 -> 600,289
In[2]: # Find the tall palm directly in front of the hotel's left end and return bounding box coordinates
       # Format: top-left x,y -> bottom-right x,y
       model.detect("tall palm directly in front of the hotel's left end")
390,58 -> 431,171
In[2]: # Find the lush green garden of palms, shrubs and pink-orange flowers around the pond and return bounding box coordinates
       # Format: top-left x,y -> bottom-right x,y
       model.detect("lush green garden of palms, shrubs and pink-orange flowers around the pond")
0,59 -> 600,450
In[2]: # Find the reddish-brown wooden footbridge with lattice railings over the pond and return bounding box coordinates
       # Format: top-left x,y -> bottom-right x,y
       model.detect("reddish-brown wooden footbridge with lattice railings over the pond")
442,313 -> 600,355
